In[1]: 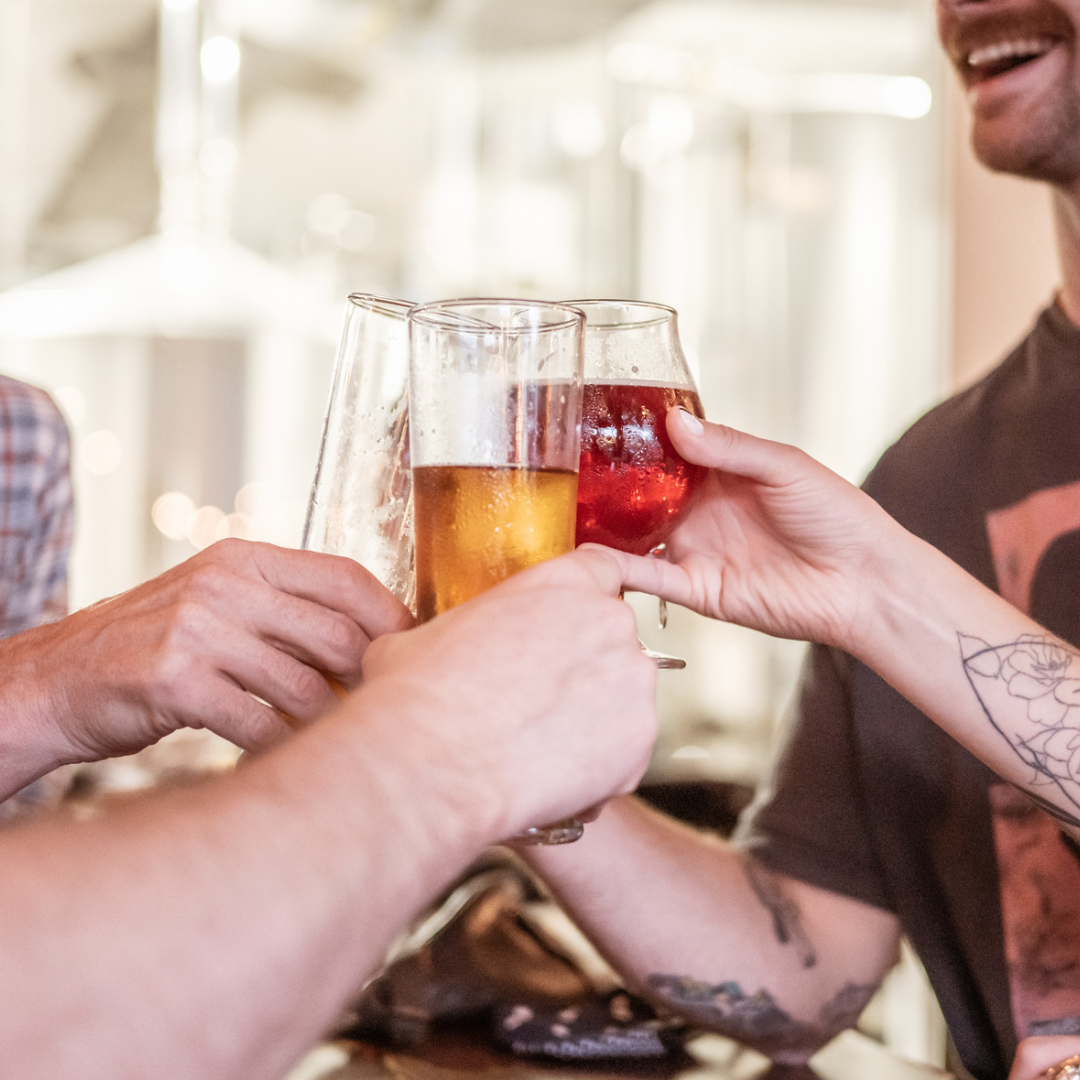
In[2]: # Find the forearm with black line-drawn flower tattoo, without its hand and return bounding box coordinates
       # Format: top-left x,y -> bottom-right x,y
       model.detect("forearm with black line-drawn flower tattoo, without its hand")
845,528 -> 1080,835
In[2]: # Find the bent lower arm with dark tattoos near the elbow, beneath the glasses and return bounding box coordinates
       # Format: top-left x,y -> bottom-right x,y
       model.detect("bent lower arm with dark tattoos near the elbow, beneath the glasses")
518,799 -> 896,1059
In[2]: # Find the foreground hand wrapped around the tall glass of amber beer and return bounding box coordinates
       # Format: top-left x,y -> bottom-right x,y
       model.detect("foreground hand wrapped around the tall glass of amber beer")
356,549 -> 657,841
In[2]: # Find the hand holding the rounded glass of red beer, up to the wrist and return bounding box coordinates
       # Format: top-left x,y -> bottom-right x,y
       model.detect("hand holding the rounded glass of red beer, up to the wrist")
624,409 -> 902,647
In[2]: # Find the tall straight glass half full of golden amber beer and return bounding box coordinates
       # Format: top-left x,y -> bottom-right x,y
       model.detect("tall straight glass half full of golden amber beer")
408,299 -> 584,843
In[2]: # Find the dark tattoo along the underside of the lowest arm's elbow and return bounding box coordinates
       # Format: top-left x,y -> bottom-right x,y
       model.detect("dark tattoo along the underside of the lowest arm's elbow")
649,975 -> 877,1057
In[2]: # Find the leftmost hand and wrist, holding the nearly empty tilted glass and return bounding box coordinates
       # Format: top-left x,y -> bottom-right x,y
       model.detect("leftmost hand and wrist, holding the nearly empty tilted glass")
0,540 -> 411,794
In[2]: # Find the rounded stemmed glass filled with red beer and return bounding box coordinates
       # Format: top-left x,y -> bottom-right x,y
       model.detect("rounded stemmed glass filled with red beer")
568,300 -> 705,669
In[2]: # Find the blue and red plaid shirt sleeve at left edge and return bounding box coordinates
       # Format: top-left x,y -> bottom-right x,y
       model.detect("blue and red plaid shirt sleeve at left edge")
0,376 -> 75,637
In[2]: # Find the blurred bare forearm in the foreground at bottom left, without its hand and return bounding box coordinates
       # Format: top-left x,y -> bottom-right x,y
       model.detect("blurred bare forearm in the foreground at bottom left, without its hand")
0,686 -> 483,1080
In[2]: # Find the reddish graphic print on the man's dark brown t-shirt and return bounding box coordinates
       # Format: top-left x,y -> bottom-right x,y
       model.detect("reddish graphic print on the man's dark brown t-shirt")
986,483 -> 1080,1039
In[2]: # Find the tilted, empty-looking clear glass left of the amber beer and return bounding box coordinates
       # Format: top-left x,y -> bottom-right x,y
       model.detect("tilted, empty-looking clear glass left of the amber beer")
301,293 -> 415,608
